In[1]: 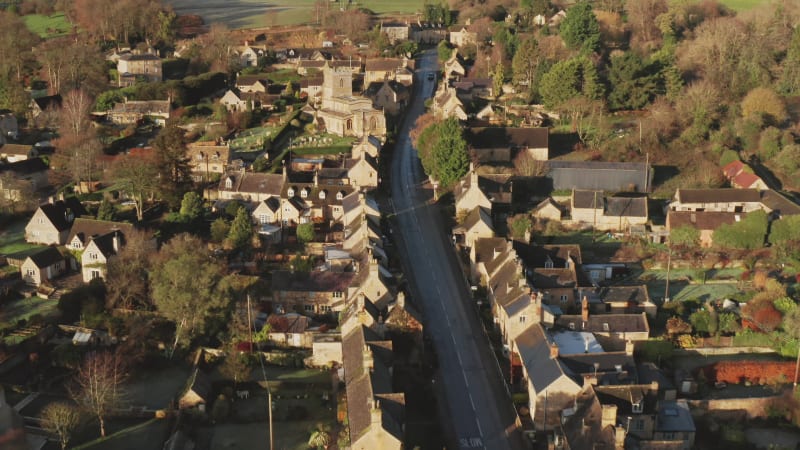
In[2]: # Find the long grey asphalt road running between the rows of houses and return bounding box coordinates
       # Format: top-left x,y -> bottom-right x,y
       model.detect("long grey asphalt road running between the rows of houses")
391,50 -> 522,450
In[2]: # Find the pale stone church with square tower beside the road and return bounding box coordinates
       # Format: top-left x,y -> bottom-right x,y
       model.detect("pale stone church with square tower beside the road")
316,63 -> 386,140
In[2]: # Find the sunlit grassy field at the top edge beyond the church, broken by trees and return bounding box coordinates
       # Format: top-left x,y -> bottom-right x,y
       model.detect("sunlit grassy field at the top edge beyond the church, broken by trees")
166,0 -> 422,28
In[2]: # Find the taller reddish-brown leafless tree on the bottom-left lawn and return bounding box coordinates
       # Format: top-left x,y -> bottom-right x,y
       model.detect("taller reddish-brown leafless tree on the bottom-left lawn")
72,351 -> 127,436
